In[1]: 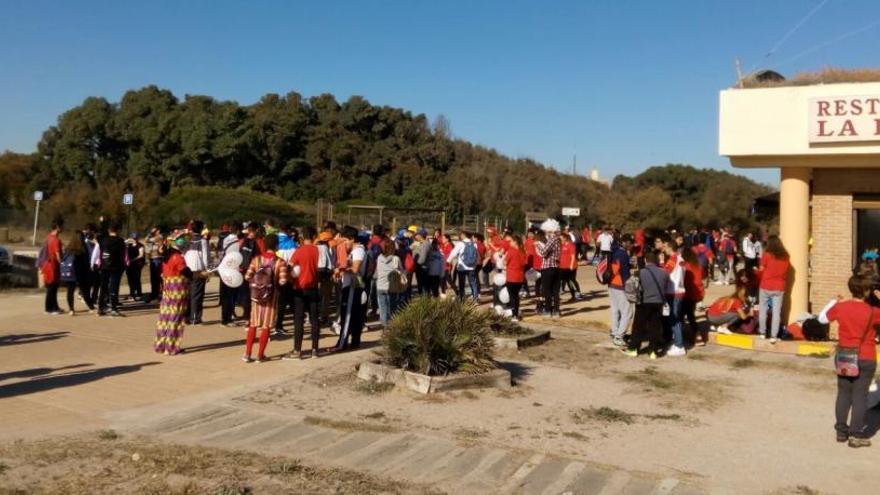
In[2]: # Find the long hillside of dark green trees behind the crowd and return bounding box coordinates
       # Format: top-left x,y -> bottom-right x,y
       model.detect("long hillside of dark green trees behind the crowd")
0,86 -> 768,232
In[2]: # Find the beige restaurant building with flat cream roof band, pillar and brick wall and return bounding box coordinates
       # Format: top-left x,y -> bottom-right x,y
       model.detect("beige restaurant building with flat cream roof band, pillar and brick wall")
719,83 -> 880,320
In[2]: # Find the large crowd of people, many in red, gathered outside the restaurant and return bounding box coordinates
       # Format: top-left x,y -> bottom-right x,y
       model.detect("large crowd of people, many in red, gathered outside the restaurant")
37,215 -> 880,447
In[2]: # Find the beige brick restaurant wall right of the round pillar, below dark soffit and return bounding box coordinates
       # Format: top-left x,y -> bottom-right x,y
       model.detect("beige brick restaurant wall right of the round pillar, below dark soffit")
810,169 -> 880,312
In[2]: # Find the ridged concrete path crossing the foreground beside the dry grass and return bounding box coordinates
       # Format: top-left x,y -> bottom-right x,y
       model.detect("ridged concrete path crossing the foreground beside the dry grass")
127,403 -> 703,495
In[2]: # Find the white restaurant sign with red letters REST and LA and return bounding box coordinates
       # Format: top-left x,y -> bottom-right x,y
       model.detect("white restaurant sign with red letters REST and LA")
809,95 -> 880,143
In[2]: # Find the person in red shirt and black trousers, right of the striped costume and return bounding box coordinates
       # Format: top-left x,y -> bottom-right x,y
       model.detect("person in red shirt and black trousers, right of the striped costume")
281,227 -> 321,360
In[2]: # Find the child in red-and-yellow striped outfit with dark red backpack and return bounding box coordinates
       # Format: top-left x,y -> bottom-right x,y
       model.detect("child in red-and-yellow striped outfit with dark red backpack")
241,234 -> 287,363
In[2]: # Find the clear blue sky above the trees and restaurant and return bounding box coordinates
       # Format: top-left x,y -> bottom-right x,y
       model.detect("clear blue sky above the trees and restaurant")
0,0 -> 880,184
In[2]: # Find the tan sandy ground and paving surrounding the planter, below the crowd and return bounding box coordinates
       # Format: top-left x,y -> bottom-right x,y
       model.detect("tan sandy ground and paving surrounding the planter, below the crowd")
0,269 -> 880,493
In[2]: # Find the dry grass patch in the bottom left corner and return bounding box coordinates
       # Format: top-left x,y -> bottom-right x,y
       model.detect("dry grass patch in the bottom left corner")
0,433 -> 437,495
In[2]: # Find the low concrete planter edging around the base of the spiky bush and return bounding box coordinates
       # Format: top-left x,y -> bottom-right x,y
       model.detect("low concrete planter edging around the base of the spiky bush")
357,361 -> 511,394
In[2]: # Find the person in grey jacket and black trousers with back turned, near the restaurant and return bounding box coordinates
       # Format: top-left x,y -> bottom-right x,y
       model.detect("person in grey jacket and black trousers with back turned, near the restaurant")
624,249 -> 669,359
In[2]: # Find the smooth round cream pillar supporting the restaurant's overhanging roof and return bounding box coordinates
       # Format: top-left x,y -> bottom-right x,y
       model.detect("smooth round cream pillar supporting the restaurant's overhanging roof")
779,167 -> 812,323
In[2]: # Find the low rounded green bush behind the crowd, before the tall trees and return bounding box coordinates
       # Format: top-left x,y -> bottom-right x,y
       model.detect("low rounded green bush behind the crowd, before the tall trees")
155,186 -> 313,228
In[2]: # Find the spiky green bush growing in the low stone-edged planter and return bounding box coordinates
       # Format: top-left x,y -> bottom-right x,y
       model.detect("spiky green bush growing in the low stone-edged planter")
381,297 -> 495,376
